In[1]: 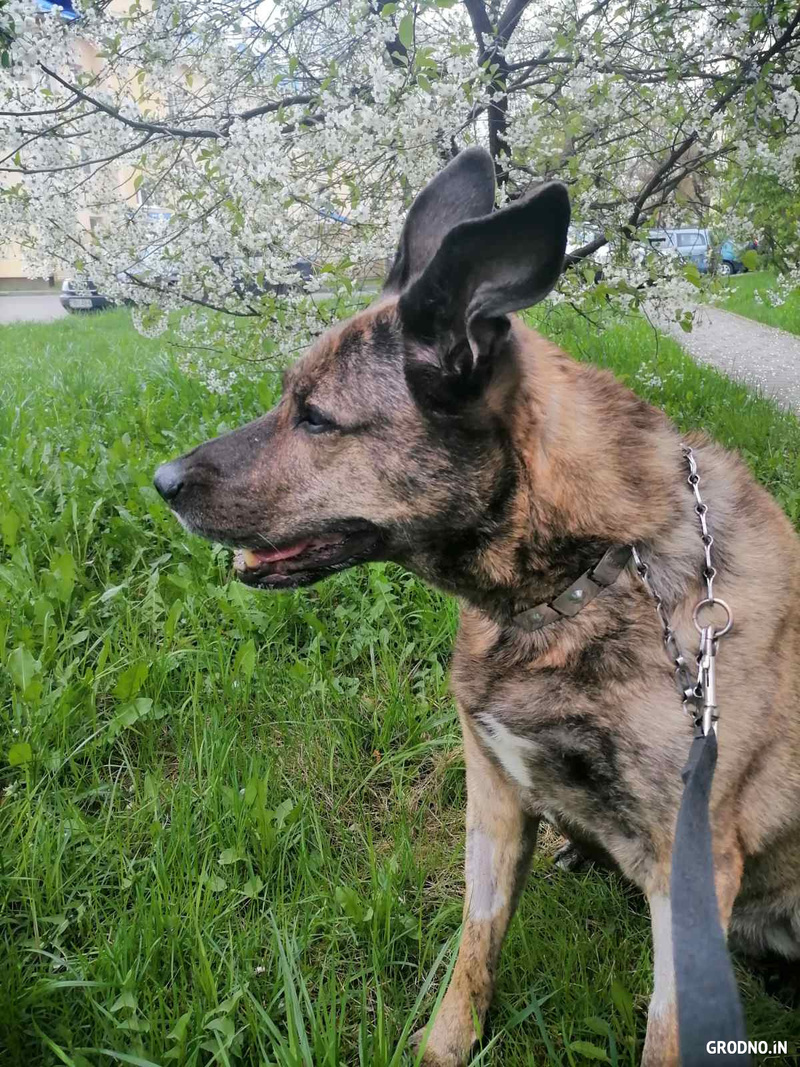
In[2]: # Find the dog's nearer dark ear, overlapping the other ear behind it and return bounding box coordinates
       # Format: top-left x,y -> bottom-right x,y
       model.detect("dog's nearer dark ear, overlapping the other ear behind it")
398,181 -> 570,373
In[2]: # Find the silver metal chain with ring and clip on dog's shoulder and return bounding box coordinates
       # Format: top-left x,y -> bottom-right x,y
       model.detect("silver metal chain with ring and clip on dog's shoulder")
633,445 -> 733,737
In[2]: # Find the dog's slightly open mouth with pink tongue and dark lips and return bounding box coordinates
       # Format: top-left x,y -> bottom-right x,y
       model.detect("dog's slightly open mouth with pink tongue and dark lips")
234,524 -> 383,589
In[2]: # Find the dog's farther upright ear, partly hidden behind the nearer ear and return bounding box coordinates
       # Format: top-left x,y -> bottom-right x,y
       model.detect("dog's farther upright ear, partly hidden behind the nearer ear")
383,148 -> 495,293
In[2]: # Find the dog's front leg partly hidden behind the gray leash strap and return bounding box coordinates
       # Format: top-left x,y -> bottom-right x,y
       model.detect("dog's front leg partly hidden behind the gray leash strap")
642,839 -> 743,1067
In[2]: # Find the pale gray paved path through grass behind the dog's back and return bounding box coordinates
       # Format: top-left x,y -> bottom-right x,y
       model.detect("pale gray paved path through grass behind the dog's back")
652,307 -> 800,412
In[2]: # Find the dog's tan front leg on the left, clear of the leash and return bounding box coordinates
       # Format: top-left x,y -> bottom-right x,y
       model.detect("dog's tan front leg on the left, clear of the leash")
415,715 -> 539,1067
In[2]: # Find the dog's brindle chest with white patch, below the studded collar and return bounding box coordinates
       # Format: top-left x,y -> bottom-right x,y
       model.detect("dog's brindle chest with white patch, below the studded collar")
452,631 -> 679,843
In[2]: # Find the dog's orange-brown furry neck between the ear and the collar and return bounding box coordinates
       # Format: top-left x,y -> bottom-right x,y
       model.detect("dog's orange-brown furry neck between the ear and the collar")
422,323 -> 691,622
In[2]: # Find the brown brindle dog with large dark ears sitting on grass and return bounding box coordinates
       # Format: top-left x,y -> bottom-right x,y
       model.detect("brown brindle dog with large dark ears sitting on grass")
156,149 -> 800,1067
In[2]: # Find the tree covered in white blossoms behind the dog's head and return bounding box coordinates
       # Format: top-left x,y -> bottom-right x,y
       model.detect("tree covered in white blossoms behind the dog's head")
0,0 -> 800,371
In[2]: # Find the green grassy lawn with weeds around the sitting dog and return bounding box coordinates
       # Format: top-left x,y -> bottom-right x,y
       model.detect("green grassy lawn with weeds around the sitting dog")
0,308 -> 800,1067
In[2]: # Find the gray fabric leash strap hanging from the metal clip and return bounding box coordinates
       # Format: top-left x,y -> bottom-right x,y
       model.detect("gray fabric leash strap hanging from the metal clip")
671,730 -> 751,1067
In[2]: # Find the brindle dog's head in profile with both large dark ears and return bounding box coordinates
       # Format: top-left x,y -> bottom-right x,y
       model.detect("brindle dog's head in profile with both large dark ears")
156,149 -> 570,589
